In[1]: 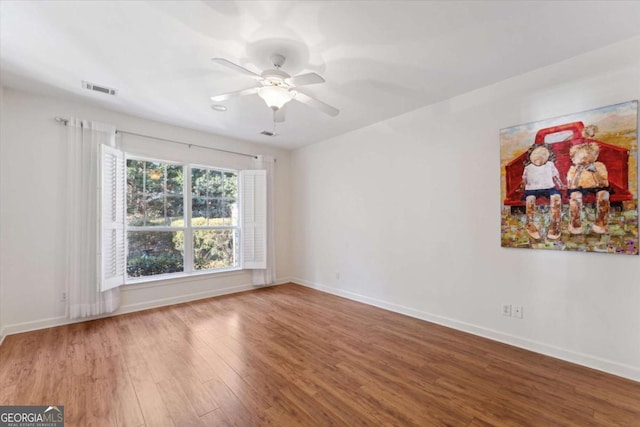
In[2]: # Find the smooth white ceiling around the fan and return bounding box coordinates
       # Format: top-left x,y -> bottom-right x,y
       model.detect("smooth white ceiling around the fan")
0,0 -> 640,148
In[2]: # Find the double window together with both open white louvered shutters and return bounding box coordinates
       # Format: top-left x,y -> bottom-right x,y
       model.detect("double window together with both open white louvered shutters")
100,147 -> 266,290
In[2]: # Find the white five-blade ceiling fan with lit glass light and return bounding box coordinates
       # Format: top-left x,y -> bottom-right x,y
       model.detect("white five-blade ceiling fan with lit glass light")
211,54 -> 340,122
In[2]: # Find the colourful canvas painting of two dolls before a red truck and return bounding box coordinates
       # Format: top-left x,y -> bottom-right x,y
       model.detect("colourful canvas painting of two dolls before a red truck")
500,101 -> 638,255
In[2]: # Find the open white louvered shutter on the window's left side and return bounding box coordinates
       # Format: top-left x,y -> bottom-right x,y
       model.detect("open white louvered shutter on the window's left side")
99,145 -> 126,291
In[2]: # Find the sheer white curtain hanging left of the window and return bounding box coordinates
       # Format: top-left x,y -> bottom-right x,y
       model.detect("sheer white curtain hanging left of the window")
66,118 -> 120,319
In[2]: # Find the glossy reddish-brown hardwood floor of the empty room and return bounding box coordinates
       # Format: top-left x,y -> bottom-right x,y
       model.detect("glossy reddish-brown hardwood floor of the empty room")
0,284 -> 640,427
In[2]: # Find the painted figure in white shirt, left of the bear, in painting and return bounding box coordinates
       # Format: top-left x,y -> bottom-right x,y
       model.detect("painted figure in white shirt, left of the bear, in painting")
518,143 -> 565,240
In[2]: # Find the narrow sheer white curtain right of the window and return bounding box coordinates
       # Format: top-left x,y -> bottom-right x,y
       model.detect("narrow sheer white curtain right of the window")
253,155 -> 276,286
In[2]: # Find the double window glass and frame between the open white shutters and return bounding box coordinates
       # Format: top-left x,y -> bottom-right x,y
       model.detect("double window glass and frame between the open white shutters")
126,158 -> 240,278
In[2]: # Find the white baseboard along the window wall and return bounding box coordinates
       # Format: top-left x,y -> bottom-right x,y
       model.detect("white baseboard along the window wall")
0,278 -> 284,344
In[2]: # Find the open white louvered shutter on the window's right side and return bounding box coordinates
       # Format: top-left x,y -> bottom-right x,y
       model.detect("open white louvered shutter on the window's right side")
240,170 -> 267,269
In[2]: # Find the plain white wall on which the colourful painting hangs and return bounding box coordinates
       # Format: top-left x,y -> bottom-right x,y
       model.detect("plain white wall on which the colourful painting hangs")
291,38 -> 640,380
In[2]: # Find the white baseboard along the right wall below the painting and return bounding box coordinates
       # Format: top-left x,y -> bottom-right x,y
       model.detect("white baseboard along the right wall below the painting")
291,277 -> 640,382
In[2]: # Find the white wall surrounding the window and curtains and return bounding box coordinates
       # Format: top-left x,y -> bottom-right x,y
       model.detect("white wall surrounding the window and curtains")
0,88 -> 290,333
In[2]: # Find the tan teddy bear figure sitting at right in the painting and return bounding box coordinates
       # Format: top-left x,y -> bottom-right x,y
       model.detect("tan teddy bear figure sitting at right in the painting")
567,142 -> 610,234
